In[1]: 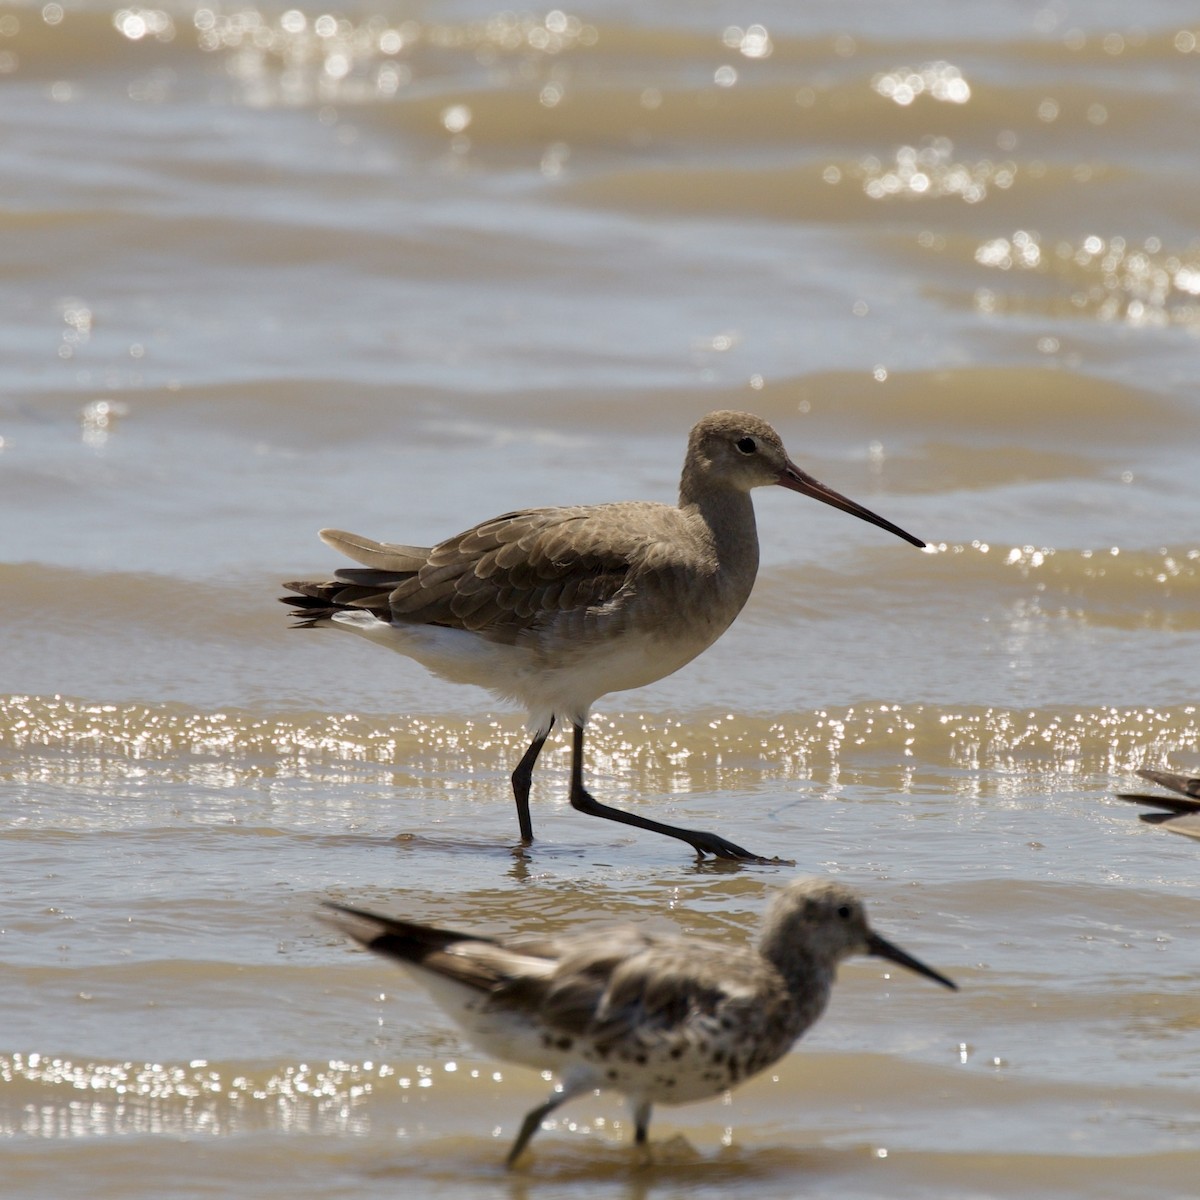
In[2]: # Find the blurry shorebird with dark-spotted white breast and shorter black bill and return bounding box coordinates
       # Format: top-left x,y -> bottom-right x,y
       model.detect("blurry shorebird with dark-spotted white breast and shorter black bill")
321,880 -> 955,1166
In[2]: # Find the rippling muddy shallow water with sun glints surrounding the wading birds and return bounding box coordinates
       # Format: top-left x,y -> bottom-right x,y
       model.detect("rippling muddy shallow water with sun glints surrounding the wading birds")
0,0 -> 1200,1200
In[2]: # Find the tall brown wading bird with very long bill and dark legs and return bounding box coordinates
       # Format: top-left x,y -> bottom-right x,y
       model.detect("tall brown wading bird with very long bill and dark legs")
282,412 -> 925,859
